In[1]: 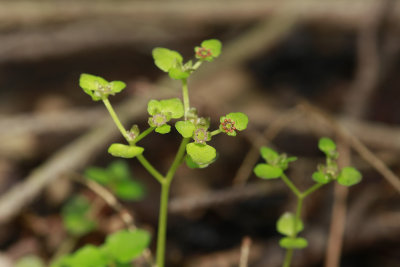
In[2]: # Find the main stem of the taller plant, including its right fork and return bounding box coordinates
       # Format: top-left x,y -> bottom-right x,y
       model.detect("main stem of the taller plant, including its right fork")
156,138 -> 190,267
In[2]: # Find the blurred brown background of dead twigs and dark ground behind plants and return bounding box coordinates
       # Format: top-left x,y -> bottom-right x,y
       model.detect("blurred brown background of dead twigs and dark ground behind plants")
0,0 -> 400,267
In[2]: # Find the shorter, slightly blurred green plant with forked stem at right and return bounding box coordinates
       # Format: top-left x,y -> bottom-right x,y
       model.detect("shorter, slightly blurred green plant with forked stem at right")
254,137 -> 362,267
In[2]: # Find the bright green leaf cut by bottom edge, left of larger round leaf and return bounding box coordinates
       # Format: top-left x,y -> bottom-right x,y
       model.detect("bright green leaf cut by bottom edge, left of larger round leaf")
69,245 -> 108,267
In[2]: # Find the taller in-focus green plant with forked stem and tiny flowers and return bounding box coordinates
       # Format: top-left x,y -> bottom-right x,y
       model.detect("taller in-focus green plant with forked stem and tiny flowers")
79,39 -> 248,267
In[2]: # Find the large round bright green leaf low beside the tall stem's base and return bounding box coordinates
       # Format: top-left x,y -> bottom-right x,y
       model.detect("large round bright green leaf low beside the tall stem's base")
104,229 -> 150,263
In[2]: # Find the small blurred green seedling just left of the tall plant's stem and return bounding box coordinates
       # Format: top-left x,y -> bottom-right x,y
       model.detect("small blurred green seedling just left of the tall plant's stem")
85,160 -> 146,201
